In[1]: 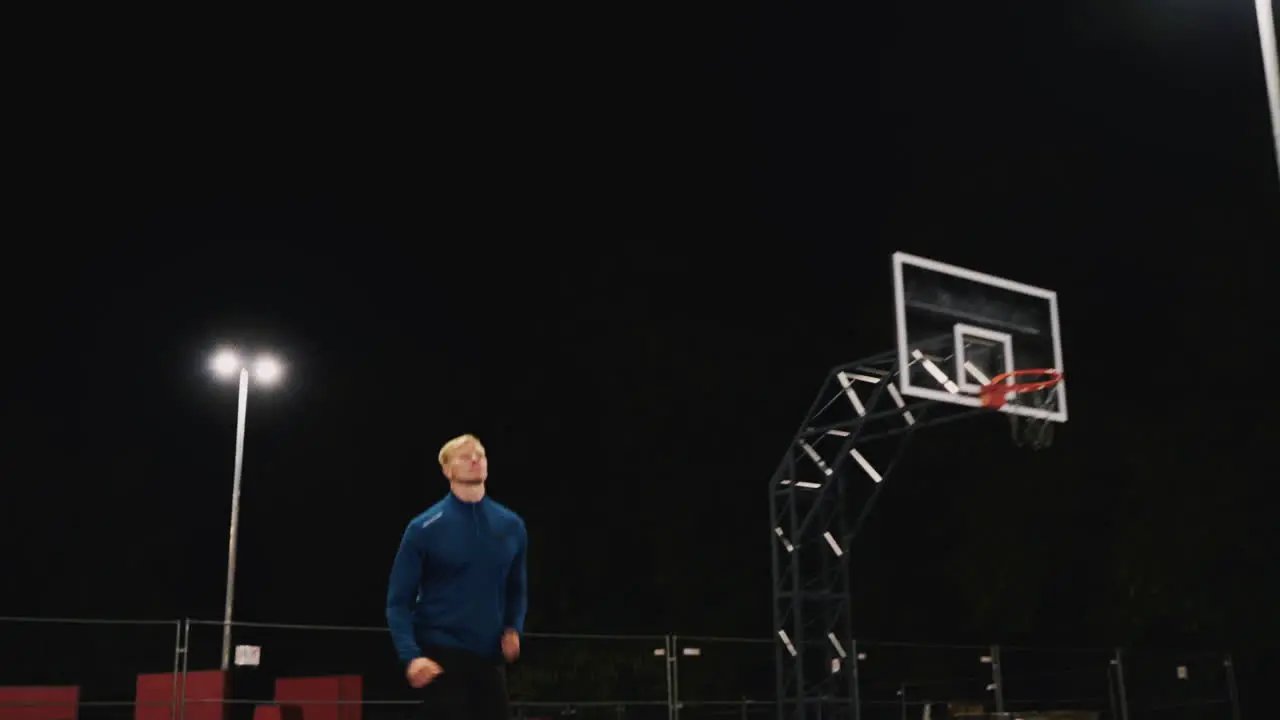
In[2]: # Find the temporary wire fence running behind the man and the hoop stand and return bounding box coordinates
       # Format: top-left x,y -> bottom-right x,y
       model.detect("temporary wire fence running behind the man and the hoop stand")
0,618 -> 1240,720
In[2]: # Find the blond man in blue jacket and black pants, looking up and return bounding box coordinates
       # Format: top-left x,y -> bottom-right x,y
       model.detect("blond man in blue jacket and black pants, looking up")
387,434 -> 529,720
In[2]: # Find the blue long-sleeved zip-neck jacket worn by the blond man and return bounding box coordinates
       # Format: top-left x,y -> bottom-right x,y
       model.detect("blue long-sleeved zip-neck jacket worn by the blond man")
387,492 -> 529,662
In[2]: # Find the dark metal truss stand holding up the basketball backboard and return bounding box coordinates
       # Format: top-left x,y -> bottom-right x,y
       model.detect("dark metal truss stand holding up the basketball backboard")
769,337 -> 989,720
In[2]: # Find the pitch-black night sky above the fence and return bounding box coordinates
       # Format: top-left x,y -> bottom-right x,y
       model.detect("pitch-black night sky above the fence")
0,0 -> 1280,712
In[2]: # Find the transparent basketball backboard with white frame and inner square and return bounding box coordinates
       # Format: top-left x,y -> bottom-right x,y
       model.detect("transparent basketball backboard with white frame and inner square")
893,252 -> 1066,423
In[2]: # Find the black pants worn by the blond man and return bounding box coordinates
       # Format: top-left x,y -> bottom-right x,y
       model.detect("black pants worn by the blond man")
419,640 -> 511,720
